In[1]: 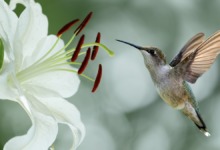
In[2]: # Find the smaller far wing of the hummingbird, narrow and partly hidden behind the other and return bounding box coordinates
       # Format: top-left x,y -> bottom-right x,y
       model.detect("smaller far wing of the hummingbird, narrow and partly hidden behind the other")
170,33 -> 205,67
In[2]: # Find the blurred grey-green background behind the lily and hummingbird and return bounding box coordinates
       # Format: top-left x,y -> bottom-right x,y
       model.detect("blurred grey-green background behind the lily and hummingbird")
0,0 -> 220,150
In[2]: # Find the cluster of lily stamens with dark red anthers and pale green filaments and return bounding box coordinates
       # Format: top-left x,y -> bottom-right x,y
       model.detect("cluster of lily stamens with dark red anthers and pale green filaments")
17,13 -> 113,92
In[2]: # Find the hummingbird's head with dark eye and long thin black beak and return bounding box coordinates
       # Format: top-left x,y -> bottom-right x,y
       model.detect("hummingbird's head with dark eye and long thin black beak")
117,40 -> 166,68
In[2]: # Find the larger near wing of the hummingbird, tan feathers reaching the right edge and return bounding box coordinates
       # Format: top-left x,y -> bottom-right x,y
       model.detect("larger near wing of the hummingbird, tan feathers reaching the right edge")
173,31 -> 220,83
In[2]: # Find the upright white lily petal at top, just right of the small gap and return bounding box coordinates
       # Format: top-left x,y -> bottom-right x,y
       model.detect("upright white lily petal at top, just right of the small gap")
14,1 -> 48,71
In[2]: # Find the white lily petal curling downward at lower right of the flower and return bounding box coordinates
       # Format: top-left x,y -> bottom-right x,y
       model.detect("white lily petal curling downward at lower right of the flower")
30,97 -> 85,149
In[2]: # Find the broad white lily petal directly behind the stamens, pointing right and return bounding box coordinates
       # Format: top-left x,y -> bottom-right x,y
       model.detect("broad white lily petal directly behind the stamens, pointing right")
23,35 -> 80,98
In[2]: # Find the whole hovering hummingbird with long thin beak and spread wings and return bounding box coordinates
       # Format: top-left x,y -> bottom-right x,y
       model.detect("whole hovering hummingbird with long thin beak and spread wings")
117,31 -> 220,136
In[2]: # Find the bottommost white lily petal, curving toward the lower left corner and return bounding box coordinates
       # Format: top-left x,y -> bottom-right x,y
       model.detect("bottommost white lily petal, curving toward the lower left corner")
4,108 -> 58,150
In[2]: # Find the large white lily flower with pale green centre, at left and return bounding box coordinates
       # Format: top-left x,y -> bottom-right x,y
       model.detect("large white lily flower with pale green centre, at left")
0,0 -> 113,150
